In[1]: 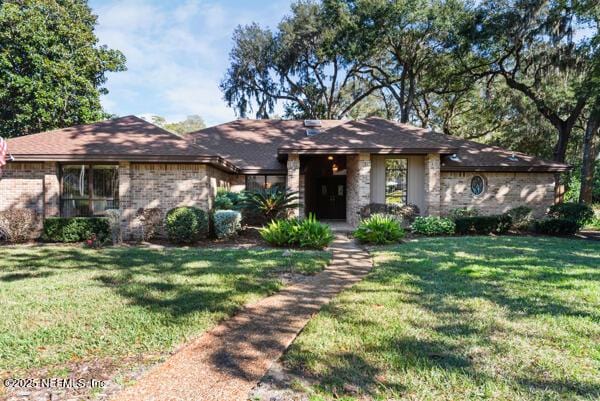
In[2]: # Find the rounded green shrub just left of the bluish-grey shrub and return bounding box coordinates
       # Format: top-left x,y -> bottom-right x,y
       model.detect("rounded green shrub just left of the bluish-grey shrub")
166,206 -> 208,244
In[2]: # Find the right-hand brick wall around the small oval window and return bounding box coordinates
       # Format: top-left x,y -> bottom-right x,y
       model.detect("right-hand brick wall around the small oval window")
441,172 -> 554,217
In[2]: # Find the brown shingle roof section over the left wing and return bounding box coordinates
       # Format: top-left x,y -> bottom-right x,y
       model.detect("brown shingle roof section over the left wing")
7,116 -> 237,171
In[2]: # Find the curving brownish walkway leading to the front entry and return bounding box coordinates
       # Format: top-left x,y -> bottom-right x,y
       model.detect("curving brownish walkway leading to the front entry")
114,234 -> 372,401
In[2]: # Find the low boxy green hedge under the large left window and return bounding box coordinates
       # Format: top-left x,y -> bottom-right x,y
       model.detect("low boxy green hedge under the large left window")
43,217 -> 111,242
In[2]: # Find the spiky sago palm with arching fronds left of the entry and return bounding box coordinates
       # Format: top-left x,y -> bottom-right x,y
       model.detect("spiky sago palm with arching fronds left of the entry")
244,188 -> 300,221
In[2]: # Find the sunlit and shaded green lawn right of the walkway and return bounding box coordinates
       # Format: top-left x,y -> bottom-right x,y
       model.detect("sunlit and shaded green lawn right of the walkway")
284,237 -> 600,401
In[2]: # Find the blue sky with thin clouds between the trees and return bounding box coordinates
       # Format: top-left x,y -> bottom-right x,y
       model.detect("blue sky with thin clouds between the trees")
89,0 -> 291,125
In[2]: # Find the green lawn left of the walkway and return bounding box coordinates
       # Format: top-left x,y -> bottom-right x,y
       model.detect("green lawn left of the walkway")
0,247 -> 330,376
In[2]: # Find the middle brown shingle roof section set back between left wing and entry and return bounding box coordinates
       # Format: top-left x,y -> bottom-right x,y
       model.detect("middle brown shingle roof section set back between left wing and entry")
186,120 -> 344,172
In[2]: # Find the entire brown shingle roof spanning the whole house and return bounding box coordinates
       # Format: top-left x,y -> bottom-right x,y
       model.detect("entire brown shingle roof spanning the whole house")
8,116 -> 569,173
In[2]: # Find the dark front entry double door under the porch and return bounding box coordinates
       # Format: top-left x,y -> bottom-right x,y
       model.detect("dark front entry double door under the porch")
315,176 -> 346,220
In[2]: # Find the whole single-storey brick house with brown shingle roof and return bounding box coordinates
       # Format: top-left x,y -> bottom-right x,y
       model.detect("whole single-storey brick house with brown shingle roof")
0,116 -> 569,238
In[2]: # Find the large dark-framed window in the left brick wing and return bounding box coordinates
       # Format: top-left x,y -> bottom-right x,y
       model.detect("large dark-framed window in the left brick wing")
60,164 -> 119,217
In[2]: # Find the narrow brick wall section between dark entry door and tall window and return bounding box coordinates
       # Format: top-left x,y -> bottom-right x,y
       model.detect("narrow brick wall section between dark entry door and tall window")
346,153 -> 371,226
